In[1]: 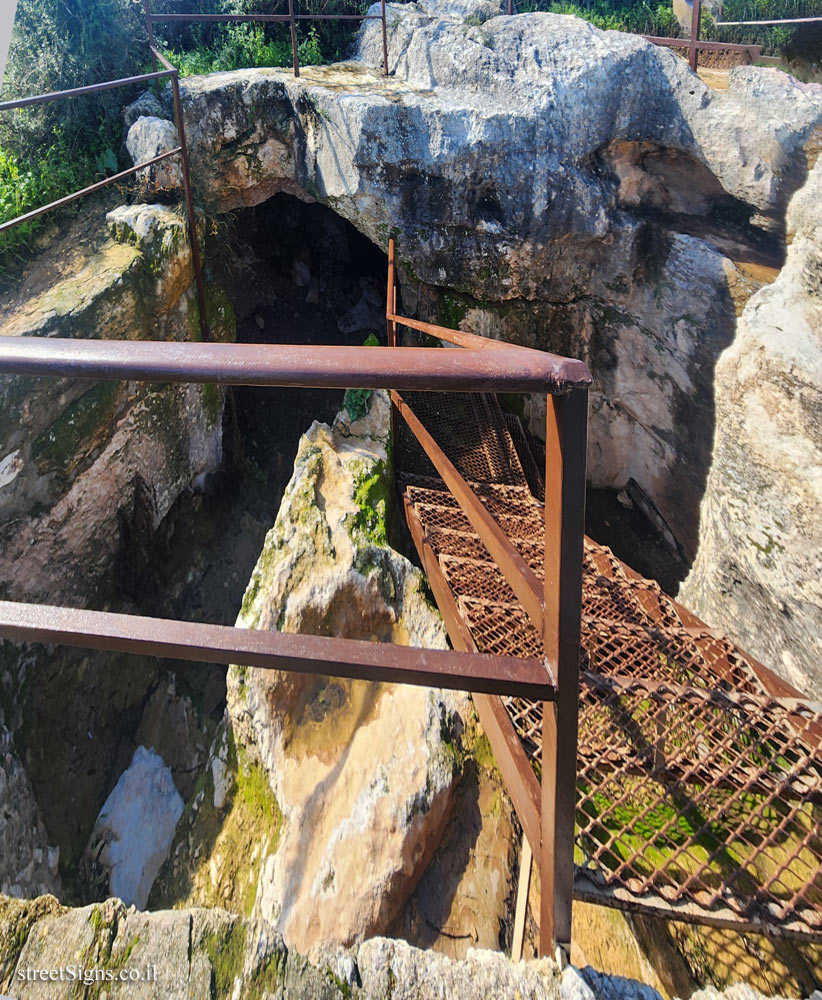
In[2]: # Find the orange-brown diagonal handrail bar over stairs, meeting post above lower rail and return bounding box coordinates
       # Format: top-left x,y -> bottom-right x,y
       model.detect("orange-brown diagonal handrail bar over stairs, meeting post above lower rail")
391,390 -> 553,640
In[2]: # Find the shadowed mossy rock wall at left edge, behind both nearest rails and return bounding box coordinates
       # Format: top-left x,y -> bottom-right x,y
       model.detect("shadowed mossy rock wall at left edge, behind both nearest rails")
0,199 -> 233,880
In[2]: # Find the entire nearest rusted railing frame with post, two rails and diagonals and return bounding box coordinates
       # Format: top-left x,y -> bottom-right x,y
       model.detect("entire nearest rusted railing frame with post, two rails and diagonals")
0,240 -> 590,953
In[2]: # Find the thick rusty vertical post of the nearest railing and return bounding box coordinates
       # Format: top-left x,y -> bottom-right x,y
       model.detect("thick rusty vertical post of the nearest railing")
539,389 -> 588,955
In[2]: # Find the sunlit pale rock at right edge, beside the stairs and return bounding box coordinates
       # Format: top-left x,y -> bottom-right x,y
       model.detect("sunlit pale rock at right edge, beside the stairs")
681,161 -> 822,700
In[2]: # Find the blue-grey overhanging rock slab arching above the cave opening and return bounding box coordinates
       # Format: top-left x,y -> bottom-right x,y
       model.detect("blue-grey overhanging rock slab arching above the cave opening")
175,2 -> 822,266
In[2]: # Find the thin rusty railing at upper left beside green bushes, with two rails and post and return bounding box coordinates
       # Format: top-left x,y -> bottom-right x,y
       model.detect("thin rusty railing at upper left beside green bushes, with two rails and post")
0,44 -> 208,340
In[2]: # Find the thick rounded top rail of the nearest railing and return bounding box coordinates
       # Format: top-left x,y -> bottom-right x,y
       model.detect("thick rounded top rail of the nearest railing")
0,336 -> 587,392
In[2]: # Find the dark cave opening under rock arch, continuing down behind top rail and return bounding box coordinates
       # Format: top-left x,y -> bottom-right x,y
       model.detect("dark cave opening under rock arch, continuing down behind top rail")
141,194 -> 387,624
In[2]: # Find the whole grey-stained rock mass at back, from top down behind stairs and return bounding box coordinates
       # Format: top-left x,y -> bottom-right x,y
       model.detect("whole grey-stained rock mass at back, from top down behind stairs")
125,0 -> 822,561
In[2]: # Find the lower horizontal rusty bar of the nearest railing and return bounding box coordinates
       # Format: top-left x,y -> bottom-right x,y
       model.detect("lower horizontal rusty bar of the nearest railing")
0,601 -> 554,700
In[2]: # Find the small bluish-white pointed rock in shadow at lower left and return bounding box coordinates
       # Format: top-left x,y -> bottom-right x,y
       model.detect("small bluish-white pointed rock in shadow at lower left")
87,747 -> 183,910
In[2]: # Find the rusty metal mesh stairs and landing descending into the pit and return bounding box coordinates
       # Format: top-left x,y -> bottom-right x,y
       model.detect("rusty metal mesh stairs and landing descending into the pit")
399,393 -> 822,940
